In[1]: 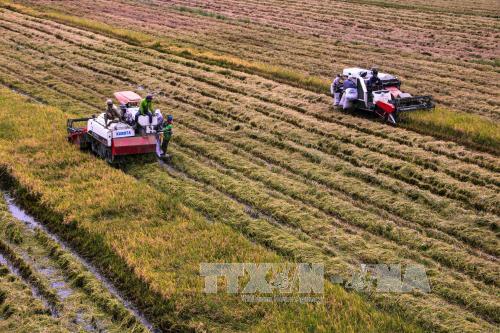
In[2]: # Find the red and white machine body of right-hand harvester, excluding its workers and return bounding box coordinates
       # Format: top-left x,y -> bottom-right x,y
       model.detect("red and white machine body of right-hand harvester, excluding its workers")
342,67 -> 435,124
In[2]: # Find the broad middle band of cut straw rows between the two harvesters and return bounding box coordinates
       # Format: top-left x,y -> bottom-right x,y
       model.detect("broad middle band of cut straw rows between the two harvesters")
0,1 -> 500,332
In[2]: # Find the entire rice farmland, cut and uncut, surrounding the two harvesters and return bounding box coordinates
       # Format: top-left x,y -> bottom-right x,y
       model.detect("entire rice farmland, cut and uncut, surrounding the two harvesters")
0,0 -> 500,332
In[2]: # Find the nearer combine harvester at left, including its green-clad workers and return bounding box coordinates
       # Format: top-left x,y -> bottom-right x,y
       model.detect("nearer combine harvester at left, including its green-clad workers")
67,91 -> 173,163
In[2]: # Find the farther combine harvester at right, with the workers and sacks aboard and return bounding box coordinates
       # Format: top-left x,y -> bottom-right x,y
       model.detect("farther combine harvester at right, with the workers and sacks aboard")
331,67 -> 434,124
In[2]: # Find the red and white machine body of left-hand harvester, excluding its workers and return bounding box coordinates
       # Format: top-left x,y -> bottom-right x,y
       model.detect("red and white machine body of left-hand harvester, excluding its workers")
67,91 -> 159,163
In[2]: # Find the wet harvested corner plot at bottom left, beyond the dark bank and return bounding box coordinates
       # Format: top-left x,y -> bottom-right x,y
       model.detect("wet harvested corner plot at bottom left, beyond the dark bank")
0,192 -> 147,333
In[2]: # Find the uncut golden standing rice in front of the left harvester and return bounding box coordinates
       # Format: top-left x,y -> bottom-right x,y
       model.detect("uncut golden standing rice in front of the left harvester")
0,89 -> 422,333
